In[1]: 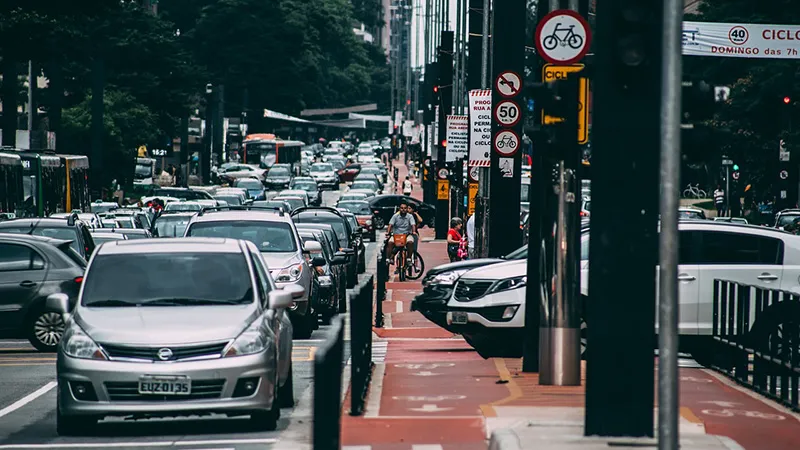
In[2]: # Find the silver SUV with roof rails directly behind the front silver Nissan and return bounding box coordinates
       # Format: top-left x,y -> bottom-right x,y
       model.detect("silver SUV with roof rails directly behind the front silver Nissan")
184,206 -> 319,339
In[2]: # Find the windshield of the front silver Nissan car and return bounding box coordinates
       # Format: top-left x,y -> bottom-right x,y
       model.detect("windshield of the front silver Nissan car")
81,252 -> 254,307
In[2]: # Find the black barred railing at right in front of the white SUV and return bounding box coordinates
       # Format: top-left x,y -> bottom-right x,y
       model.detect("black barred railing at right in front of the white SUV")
710,280 -> 800,411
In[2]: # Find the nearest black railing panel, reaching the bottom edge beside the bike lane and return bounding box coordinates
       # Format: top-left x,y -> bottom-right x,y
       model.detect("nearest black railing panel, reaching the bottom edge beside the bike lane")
313,316 -> 344,450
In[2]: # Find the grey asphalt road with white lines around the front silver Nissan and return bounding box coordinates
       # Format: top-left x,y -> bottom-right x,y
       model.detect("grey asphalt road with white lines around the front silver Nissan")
0,186 -> 376,450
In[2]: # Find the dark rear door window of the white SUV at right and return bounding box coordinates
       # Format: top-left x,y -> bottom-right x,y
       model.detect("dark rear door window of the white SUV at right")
699,231 -> 783,265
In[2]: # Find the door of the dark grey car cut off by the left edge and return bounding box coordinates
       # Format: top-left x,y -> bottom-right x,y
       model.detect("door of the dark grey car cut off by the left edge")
0,242 -> 47,330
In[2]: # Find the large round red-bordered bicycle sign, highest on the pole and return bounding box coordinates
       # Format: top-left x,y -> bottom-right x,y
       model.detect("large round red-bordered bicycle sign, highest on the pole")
534,9 -> 592,64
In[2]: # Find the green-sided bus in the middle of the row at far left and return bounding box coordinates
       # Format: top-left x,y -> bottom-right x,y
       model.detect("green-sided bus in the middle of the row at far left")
18,152 -> 66,217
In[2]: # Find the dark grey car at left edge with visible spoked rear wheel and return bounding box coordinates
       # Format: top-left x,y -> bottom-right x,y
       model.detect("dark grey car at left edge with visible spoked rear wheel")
0,233 -> 86,351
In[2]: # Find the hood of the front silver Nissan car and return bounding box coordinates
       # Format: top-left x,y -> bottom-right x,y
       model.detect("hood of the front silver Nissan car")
75,303 -> 258,345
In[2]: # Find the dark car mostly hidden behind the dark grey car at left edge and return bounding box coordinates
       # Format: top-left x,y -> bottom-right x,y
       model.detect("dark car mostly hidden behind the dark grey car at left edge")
0,213 -> 95,261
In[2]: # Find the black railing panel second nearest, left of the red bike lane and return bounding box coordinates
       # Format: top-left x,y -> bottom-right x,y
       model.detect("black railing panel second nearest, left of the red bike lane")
348,275 -> 374,416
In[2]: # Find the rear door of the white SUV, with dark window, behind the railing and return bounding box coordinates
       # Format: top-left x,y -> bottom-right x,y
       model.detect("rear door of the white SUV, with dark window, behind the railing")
697,230 -> 784,335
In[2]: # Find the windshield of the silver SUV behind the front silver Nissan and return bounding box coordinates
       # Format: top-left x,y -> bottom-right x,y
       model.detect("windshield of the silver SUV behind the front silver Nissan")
186,221 -> 297,253
